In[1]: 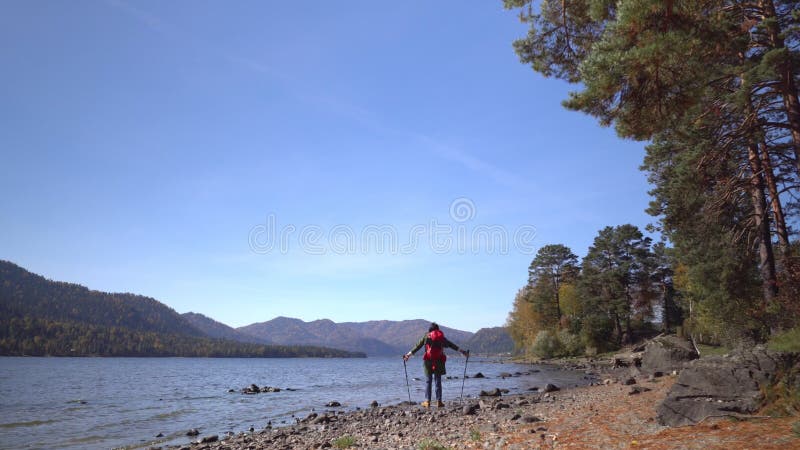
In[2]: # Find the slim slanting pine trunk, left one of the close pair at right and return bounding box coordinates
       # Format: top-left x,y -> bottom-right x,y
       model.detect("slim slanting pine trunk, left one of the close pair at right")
747,143 -> 778,303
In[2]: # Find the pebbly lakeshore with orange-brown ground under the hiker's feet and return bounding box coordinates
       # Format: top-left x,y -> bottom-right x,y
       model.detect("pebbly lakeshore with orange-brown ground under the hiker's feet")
155,360 -> 800,450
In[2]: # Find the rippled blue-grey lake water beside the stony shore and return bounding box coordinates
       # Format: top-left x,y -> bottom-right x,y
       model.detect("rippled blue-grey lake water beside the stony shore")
0,357 -> 588,449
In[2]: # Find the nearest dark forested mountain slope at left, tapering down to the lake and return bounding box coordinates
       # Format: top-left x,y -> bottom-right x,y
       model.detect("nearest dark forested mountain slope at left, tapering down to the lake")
0,260 -> 365,357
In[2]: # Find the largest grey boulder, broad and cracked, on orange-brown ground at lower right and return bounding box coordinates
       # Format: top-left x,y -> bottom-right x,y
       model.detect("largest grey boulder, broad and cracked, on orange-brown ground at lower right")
657,347 -> 796,426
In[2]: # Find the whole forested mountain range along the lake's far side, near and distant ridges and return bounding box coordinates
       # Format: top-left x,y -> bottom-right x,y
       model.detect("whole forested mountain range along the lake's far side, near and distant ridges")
0,260 -> 513,356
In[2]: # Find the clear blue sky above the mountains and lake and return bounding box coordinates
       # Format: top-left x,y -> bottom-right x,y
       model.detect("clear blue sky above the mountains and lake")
0,0 -> 652,331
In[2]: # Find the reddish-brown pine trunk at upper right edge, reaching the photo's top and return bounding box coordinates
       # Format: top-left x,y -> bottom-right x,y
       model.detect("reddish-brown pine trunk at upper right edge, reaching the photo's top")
760,0 -> 800,174
